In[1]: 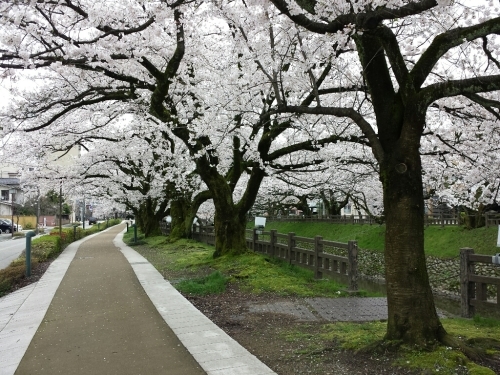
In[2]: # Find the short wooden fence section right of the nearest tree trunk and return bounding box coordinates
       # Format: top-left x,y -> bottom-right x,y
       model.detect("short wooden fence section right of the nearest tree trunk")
460,247 -> 500,318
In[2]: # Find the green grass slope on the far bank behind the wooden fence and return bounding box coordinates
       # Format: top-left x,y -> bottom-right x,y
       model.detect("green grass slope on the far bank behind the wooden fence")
254,221 -> 500,258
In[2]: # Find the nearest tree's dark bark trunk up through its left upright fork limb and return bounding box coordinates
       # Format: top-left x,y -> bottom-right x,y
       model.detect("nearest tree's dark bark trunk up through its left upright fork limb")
357,29 -> 446,347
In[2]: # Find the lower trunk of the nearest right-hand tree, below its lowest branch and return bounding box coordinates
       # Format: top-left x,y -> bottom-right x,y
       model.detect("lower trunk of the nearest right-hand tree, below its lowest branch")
381,146 -> 445,346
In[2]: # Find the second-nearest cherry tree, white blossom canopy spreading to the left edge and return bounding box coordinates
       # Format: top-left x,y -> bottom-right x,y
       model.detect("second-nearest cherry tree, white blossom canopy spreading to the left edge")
0,1 -> 366,256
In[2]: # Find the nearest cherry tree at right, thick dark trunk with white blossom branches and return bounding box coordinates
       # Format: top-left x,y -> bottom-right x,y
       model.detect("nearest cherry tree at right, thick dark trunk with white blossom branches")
262,0 -> 500,345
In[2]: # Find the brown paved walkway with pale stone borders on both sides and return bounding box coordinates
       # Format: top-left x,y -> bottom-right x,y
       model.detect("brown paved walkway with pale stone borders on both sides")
0,225 -> 274,375
